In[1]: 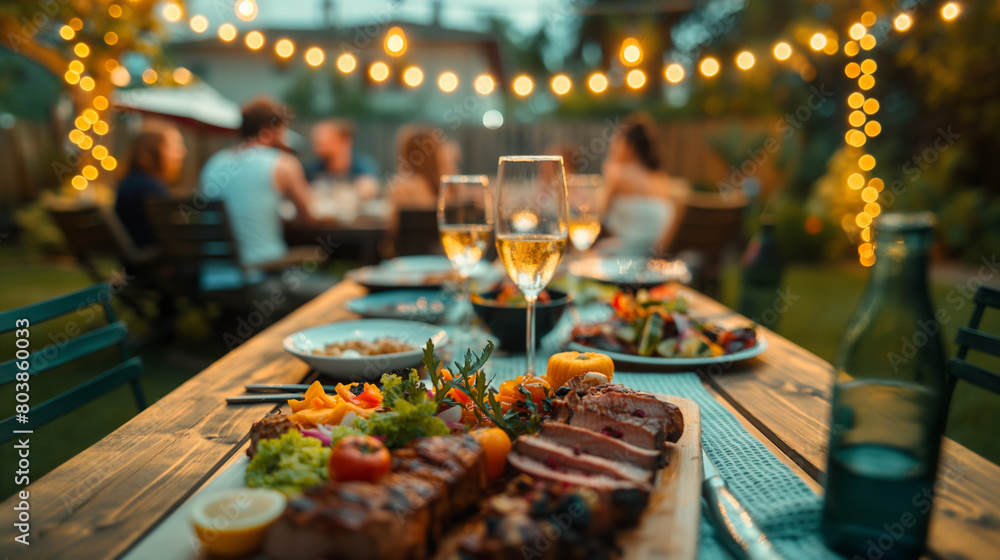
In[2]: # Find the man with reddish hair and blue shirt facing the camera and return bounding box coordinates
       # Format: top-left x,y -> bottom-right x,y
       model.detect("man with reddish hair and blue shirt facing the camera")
306,120 -> 379,200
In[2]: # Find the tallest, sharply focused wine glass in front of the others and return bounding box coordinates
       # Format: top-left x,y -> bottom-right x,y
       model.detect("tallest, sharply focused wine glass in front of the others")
496,156 -> 569,373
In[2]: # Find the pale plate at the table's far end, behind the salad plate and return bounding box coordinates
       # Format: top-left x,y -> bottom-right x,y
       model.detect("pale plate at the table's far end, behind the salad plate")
569,256 -> 691,287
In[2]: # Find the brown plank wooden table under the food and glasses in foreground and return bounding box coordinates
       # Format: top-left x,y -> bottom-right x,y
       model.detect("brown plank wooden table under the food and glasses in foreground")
0,282 -> 1000,560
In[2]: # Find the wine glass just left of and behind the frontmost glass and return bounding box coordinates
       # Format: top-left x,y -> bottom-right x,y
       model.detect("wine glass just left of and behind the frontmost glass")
438,175 -> 493,343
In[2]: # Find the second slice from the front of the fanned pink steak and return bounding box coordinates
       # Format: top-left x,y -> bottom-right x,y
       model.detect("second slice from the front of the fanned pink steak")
514,436 -> 654,490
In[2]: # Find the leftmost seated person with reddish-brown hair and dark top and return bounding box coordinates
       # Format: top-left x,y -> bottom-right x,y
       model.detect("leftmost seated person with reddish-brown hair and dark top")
115,121 -> 187,249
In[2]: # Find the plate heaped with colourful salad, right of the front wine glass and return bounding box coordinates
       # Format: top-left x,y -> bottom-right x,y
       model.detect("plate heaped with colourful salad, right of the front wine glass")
567,288 -> 767,366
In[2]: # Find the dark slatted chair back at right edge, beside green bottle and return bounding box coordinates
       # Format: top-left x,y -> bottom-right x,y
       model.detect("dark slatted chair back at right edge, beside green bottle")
948,286 -> 1000,410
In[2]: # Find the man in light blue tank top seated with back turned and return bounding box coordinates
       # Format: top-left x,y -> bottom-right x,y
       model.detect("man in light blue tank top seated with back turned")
199,98 -> 333,303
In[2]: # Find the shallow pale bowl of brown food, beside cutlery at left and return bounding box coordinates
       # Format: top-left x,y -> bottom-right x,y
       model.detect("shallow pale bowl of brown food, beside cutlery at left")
283,319 -> 448,382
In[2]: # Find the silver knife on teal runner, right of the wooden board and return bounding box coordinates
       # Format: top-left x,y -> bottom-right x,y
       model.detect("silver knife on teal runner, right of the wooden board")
701,449 -> 784,560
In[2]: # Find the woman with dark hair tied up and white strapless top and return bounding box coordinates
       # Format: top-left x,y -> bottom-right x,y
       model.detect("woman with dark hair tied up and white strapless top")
601,114 -> 687,255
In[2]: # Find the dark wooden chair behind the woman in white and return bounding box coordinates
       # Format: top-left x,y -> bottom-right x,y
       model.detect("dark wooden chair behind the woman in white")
665,193 -> 747,296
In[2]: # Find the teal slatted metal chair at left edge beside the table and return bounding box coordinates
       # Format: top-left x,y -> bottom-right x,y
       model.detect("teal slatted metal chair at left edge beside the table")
0,282 -> 146,443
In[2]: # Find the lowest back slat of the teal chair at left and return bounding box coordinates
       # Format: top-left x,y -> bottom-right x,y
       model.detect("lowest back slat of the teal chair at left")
0,357 -> 142,443
